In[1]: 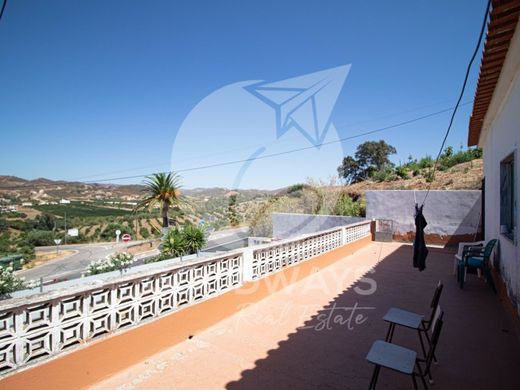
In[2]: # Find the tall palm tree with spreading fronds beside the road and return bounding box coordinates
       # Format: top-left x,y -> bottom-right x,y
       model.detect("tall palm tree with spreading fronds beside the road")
136,172 -> 181,228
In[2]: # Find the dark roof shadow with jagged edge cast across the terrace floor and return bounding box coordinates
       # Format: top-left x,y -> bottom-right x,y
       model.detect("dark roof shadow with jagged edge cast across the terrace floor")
227,243 -> 520,390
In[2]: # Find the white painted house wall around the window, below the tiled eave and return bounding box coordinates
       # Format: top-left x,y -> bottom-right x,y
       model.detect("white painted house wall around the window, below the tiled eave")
480,67 -> 520,313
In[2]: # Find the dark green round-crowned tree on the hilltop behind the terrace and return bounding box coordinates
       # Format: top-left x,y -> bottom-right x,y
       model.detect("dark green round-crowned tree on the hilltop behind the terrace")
338,140 -> 397,184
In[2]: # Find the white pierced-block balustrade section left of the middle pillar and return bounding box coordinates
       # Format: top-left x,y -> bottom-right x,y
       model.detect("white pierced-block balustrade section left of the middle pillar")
0,253 -> 243,374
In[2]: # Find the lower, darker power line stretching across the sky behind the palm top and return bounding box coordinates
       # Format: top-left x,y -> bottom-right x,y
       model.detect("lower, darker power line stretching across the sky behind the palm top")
0,101 -> 473,190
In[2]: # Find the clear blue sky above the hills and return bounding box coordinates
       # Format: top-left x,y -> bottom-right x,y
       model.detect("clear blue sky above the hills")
0,0 -> 486,188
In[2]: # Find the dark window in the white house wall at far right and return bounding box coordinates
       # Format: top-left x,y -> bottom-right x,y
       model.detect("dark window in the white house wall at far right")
500,153 -> 516,240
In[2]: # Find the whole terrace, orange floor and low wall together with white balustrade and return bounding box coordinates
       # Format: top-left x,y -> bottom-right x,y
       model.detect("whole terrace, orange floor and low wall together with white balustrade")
0,223 -> 520,389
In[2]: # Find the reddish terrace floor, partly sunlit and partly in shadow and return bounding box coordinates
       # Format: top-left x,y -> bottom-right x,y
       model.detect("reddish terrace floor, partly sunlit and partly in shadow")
92,243 -> 520,390
